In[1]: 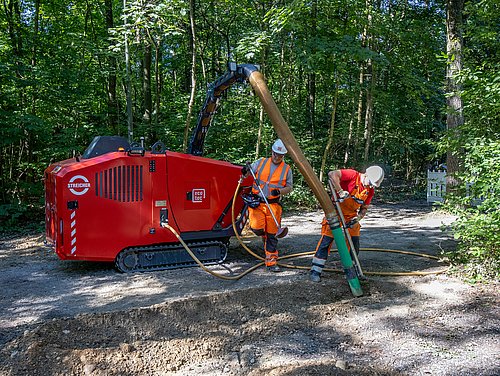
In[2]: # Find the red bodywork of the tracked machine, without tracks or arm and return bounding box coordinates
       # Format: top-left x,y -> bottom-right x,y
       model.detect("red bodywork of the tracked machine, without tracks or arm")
45,151 -> 249,261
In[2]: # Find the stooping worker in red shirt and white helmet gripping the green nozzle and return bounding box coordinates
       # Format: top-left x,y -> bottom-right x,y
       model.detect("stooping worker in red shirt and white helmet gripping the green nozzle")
310,166 -> 384,282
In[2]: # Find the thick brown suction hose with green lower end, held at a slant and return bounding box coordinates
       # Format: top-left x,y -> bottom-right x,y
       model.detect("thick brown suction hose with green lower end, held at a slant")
248,69 -> 363,296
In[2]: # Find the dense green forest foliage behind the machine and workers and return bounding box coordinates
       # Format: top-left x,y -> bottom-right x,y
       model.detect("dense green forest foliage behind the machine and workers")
0,0 -> 494,245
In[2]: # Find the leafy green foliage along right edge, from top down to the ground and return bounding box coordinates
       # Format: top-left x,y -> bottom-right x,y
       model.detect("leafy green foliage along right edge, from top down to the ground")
437,0 -> 500,281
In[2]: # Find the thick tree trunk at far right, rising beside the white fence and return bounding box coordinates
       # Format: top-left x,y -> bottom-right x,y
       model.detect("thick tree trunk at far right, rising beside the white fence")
446,0 -> 464,188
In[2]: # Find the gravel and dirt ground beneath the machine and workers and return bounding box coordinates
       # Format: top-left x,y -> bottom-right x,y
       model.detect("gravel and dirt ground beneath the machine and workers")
0,202 -> 500,376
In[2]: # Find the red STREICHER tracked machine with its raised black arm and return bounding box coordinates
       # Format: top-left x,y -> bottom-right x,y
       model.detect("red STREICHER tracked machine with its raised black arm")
45,64 -> 257,272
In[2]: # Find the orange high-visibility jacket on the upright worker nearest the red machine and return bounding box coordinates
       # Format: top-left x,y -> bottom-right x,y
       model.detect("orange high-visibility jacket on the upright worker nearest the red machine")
252,158 -> 290,201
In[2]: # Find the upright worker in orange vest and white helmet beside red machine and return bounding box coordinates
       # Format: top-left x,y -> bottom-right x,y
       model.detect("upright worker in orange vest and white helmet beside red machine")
241,139 -> 293,272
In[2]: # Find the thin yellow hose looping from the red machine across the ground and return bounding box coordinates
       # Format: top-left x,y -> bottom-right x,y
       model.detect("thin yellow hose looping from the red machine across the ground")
162,180 -> 450,281
